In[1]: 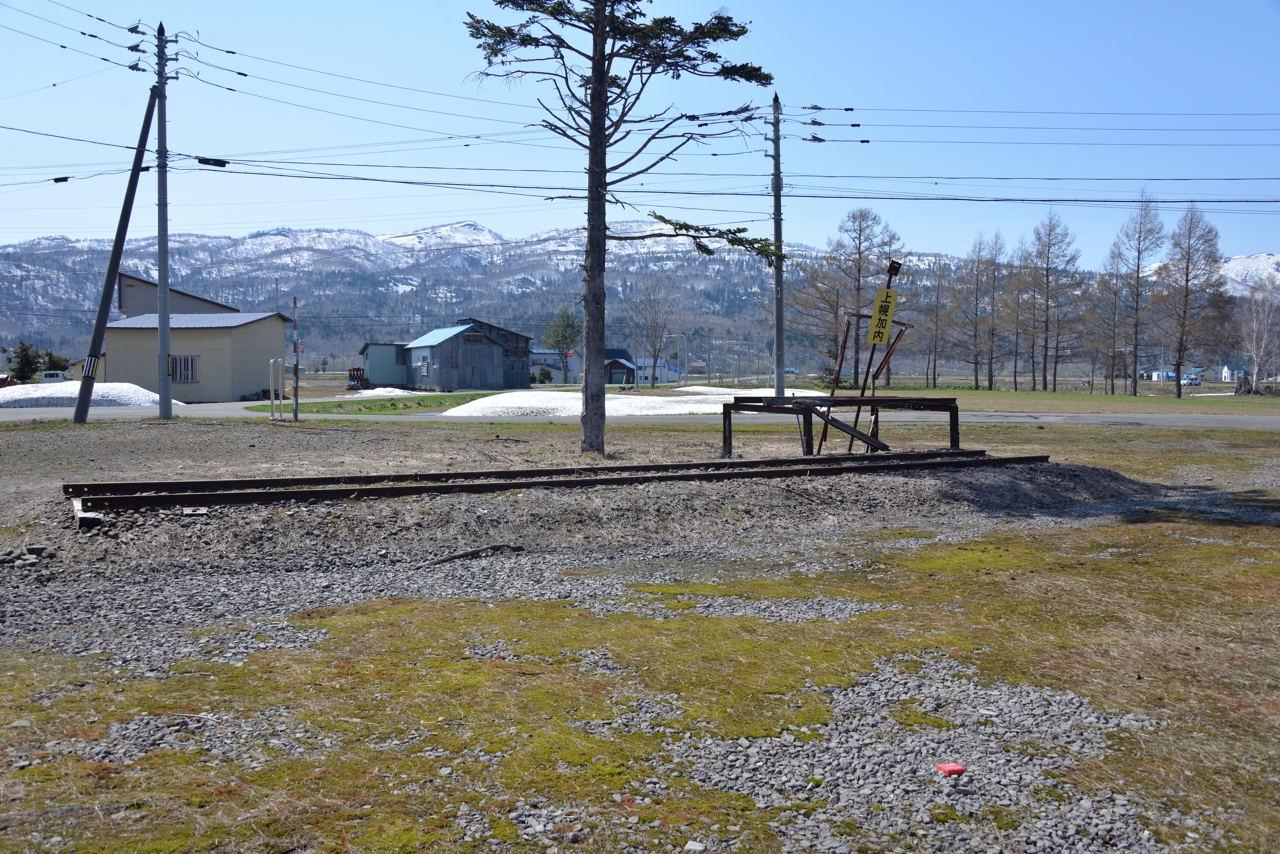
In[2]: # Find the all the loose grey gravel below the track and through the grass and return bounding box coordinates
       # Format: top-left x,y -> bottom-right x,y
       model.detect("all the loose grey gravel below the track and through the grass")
0,428 -> 1275,854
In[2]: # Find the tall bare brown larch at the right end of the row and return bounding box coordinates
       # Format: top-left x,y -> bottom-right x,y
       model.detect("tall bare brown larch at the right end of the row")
1156,204 -> 1226,397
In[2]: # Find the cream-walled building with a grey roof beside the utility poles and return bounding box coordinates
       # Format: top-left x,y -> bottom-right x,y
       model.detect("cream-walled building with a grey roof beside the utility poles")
99,312 -> 292,403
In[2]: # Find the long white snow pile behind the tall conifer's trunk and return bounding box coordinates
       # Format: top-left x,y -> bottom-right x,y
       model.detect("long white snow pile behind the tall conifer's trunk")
440,385 -> 818,417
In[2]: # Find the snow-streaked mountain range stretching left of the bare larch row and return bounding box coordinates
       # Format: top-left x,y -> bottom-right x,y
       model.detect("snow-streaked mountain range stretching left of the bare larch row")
0,222 -> 815,353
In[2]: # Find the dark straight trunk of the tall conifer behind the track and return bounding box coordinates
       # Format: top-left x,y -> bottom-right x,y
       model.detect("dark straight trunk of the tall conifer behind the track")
582,0 -> 609,455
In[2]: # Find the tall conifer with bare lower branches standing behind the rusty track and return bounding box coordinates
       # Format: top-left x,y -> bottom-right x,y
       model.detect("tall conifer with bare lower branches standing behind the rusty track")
466,0 -> 782,453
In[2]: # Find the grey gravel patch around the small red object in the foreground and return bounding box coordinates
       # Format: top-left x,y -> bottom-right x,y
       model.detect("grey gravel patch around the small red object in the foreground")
666,657 -> 1187,851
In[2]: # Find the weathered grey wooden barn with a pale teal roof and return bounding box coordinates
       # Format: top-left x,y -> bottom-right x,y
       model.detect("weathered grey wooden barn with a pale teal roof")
404,318 -> 532,392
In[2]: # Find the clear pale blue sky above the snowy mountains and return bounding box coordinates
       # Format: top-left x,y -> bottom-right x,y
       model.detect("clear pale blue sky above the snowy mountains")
0,0 -> 1280,266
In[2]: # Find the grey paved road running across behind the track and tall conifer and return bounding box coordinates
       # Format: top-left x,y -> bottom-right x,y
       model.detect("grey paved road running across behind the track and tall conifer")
0,403 -> 1280,430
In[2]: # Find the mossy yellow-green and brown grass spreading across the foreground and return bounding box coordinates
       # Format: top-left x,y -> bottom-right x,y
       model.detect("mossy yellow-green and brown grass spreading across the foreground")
0,425 -> 1280,853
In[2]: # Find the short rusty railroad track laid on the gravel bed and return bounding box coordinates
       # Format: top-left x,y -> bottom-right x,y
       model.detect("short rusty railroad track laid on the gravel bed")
63,451 -> 1048,512
